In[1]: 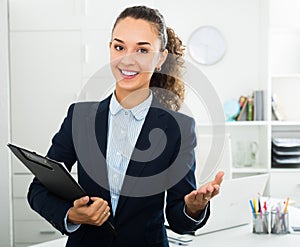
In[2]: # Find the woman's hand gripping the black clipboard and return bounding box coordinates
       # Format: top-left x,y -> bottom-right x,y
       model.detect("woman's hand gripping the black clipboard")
68,196 -> 110,226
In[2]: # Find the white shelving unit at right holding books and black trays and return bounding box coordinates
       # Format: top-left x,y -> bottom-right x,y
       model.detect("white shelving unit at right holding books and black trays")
220,0 -> 300,205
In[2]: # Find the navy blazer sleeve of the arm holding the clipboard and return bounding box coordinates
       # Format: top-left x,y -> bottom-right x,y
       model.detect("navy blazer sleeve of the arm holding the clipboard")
27,104 -> 76,234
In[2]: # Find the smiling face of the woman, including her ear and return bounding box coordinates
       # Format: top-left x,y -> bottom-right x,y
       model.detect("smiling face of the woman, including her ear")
110,17 -> 167,95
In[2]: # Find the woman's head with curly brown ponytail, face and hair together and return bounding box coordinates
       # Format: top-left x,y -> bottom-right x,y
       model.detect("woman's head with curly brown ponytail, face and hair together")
110,7 -> 184,110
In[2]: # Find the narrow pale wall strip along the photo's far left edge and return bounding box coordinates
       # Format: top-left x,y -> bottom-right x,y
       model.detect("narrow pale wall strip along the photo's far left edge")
0,0 -> 12,246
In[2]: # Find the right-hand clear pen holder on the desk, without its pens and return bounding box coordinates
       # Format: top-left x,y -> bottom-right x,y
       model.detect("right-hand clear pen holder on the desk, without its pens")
271,211 -> 290,234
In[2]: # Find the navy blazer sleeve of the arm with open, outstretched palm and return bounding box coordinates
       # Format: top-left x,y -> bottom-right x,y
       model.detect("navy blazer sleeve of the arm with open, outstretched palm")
166,117 -> 210,234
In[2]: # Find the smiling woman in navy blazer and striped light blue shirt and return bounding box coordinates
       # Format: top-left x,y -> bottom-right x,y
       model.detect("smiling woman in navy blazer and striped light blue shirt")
28,6 -> 223,246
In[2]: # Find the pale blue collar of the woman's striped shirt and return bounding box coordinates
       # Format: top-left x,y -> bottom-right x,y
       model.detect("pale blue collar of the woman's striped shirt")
109,90 -> 153,120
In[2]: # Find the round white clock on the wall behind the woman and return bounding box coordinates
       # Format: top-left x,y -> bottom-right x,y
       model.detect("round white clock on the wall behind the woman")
188,26 -> 226,65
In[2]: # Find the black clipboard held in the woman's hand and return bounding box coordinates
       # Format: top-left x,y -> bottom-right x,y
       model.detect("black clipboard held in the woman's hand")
7,144 -> 87,202
